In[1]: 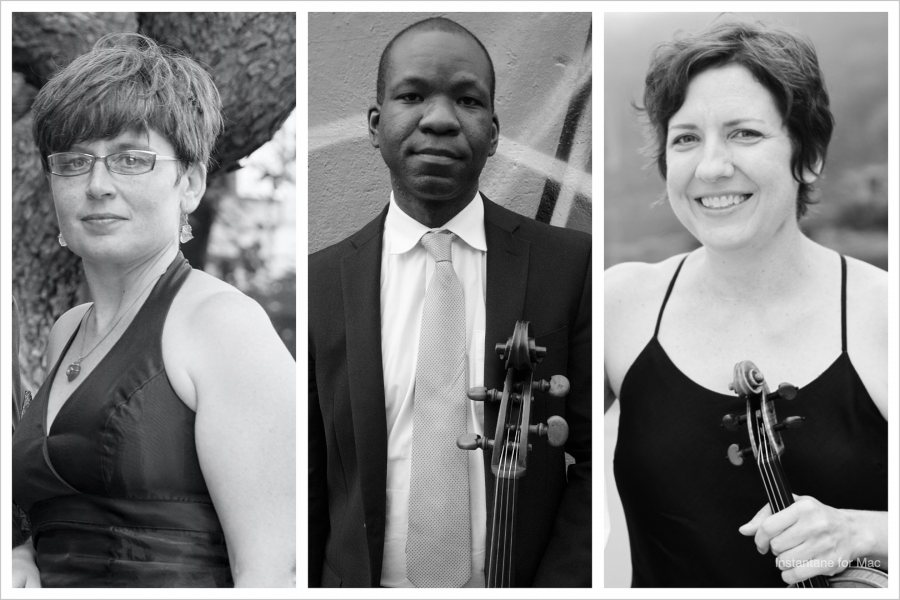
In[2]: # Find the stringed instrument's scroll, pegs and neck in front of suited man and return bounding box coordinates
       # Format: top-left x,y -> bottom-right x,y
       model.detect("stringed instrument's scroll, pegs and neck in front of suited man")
456,321 -> 569,588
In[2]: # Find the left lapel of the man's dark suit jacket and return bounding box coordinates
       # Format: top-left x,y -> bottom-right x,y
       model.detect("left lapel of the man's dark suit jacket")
335,209 -> 387,577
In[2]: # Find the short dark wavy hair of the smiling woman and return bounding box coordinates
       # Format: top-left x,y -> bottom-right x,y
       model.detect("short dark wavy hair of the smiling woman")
639,22 -> 834,218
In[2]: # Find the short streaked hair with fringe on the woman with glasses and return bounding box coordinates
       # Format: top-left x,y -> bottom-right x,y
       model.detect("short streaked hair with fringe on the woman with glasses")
32,33 -> 222,169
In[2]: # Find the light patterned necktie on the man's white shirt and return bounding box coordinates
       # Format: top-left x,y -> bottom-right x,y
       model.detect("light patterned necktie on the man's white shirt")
406,231 -> 472,587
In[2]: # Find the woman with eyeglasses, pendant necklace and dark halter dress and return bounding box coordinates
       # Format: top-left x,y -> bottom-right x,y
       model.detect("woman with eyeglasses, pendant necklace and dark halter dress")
12,34 -> 296,587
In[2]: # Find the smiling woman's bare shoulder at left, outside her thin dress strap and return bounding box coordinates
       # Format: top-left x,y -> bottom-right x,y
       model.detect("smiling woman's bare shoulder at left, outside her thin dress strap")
603,254 -> 684,396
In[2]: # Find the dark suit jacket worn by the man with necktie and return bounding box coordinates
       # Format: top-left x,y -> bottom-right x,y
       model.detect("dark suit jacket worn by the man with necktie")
309,201 -> 591,587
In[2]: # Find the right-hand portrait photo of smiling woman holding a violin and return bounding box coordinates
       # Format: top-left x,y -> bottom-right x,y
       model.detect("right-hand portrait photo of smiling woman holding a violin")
603,12 -> 896,588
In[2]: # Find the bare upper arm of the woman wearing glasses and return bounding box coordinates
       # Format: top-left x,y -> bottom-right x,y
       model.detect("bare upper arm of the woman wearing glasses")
187,292 -> 296,587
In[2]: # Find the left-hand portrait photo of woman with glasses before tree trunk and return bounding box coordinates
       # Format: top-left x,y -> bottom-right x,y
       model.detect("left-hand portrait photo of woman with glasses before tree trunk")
2,9 -> 297,588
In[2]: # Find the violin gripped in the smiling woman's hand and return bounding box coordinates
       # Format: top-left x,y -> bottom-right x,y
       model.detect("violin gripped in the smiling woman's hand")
722,360 -> 887,588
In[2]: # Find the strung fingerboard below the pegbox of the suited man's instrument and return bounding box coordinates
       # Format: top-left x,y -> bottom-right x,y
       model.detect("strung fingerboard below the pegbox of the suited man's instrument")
485,477 -> 518,588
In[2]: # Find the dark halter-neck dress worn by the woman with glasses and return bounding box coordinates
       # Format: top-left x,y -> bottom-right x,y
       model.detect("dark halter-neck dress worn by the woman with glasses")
12,254 -> 233,587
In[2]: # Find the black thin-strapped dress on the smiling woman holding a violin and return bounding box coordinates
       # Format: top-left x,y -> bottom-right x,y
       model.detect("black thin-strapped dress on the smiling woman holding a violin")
614,256 -> 888,587
